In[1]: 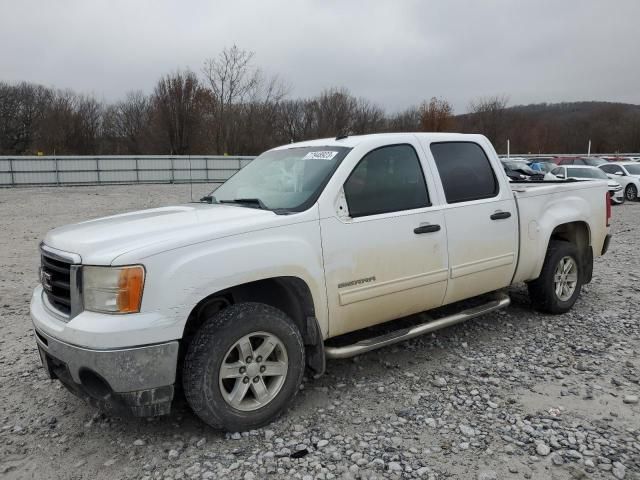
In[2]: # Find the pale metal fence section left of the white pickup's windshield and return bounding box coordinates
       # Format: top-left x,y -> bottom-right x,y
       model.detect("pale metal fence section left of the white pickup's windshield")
0,155 -> 255,187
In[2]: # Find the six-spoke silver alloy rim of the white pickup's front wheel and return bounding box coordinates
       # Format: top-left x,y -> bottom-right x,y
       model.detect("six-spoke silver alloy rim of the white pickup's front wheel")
218,332 -> 289,412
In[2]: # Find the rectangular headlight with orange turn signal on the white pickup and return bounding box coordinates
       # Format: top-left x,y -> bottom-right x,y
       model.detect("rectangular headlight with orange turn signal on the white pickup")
82,265 -> 144,313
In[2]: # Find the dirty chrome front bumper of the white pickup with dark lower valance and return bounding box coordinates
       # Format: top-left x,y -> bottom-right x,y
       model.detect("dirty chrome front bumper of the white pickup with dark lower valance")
34,322 -> 178,416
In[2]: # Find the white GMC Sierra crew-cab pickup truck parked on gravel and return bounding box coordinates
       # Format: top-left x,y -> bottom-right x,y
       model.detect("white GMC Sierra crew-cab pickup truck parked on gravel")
31,133 -> 610,431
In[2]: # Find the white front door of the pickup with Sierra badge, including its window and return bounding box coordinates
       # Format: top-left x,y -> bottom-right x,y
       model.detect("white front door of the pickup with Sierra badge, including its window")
320,142 -> 448,336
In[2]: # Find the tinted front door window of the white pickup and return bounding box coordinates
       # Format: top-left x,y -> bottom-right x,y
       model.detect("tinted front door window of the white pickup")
344,145 -> 430,217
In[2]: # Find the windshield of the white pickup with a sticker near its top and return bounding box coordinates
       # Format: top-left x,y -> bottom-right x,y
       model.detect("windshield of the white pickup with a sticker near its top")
205,146 -> 351,211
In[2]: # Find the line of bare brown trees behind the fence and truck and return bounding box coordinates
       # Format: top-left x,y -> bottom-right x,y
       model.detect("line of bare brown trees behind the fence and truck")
0,45 -> 640,155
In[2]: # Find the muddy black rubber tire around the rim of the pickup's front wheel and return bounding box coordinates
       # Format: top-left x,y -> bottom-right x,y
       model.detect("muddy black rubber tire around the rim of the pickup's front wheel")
182,303 -> 305,432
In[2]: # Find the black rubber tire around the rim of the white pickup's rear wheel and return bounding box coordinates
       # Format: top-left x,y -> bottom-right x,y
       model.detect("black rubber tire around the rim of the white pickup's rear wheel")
527,240 -> 584,314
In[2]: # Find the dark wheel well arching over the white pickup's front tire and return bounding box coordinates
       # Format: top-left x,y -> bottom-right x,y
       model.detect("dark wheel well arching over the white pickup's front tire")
181,277 -> 325,374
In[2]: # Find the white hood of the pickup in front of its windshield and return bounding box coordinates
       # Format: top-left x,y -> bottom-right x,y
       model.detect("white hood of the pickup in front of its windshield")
44,204 -> 287,265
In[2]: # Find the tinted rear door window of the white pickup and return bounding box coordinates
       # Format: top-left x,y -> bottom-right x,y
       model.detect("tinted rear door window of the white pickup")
431,142 -> 499,203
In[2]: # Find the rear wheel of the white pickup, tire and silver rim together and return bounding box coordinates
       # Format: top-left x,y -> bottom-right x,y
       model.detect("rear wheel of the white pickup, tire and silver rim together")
527,240 -> 583,314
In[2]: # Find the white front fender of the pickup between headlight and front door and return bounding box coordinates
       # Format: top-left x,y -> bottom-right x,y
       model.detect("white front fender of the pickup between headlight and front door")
142,221 -> 328,338
